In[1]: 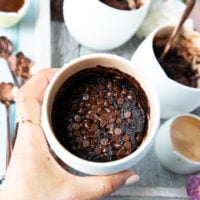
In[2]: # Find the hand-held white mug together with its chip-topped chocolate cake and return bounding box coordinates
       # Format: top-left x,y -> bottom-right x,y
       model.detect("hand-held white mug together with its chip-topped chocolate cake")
42,54 -> 159,174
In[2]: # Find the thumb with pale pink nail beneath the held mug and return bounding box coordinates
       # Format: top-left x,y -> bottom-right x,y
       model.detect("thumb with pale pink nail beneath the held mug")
67,170 -> 139,200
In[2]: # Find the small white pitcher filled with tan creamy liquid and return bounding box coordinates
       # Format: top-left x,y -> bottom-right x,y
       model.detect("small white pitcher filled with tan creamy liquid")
155,114 -> 200,174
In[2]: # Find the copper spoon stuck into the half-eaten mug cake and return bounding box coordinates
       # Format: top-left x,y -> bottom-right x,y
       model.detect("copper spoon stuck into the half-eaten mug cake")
160,0 -> 195,59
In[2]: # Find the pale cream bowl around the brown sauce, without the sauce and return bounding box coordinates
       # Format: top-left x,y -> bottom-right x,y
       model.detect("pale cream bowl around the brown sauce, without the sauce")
0,0 -> 30,28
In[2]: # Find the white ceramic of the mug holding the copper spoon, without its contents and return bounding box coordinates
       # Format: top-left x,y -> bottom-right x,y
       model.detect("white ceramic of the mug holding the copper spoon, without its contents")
131,26 -> 200,118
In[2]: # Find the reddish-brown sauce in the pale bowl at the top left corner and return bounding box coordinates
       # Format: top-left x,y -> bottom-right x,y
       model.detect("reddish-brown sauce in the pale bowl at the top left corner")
0,0 -> 25,12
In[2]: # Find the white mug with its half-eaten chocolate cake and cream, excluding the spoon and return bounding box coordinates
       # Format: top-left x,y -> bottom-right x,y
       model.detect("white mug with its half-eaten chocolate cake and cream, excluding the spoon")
132,26 -> 200,118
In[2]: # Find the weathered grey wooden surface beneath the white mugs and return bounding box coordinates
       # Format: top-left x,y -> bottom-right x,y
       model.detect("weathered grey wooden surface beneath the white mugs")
51,21 -> 200,200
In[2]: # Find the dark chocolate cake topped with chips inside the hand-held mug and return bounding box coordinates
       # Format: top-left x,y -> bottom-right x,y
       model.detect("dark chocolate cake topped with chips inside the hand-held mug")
52,66 -> 149,162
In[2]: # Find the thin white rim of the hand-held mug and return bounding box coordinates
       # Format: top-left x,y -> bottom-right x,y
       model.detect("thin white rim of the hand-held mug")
42,53 -> 160,172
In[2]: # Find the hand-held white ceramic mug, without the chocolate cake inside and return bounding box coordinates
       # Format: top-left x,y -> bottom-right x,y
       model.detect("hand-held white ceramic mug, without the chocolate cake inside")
42,54 -> 160,174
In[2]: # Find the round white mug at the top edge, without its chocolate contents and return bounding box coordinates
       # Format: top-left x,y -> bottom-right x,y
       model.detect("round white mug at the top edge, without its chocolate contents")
63,0 -> 151,50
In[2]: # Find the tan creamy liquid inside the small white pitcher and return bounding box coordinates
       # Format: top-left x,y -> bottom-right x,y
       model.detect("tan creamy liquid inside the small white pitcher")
170,116 -> 200,162
